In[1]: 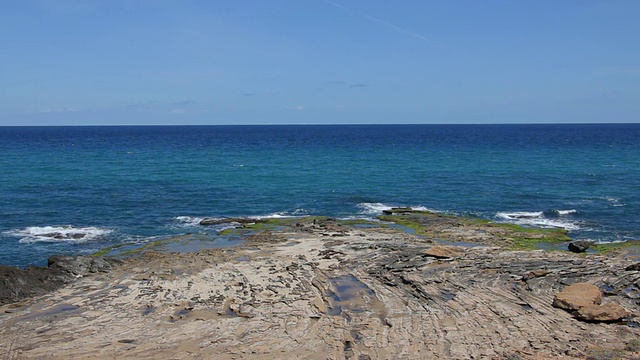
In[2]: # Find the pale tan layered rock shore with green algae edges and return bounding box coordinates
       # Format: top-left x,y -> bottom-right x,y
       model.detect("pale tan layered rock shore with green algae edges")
0,209 -> 640,360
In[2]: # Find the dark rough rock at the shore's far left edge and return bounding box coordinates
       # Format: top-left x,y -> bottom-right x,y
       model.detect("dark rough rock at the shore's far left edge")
0,255 -> 119,305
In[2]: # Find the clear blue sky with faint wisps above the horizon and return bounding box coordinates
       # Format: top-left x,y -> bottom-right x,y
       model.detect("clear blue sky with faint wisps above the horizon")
0,0 -> 640,125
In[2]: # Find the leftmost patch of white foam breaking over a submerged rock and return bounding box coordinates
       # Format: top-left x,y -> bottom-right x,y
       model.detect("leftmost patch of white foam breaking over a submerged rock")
5,225 -> 113,243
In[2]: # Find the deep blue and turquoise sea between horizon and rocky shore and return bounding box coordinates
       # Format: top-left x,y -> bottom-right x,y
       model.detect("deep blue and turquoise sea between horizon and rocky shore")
0,124 -> 640,266
